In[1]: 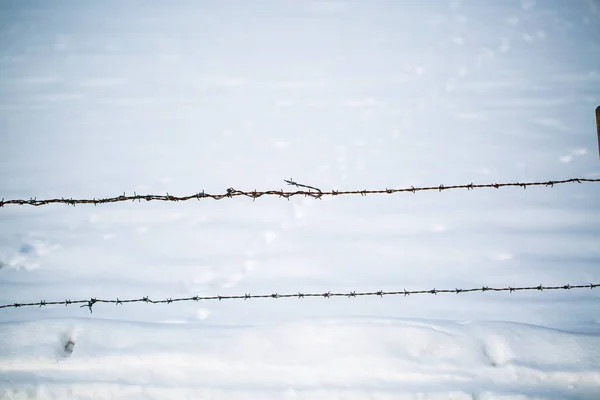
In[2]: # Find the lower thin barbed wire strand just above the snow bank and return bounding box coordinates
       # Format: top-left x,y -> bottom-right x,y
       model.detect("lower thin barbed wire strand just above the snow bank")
0,283 -> 600,313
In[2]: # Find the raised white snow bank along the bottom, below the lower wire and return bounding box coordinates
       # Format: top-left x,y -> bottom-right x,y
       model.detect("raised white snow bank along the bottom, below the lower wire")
0,318 -> 600,399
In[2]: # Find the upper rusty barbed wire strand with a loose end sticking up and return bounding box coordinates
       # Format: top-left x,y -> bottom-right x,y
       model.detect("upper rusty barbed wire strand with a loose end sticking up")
0,178 -> 600,207
